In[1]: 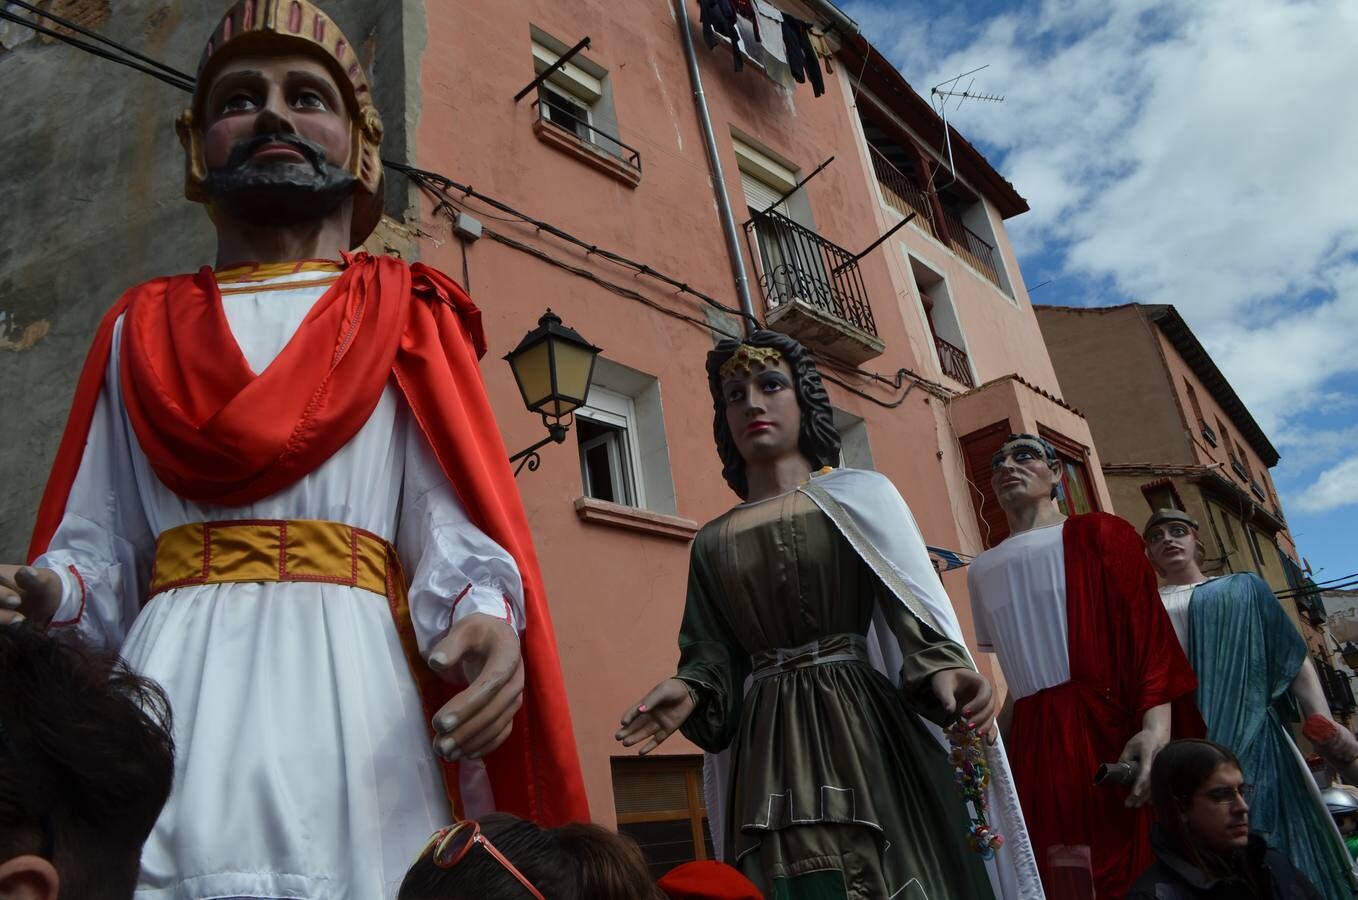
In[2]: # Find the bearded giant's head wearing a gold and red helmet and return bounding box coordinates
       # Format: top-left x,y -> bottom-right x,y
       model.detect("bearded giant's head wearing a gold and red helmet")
177,0 -> 382,246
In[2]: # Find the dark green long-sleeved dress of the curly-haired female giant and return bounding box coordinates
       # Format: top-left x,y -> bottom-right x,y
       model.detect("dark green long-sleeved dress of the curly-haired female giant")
678,491 -> 991,900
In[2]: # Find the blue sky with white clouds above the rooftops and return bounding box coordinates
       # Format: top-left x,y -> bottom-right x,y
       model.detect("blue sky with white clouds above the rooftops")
841,0 -> 1358,581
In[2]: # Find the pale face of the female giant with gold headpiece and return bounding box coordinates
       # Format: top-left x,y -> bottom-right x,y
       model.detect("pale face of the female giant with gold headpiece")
721,360 -> 801,463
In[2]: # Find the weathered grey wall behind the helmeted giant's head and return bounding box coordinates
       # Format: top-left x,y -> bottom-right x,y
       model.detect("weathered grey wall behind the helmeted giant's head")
0,0 -> 424,561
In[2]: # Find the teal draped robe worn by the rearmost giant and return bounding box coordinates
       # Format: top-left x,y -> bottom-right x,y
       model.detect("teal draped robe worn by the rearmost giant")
1187,573 -> 1354,900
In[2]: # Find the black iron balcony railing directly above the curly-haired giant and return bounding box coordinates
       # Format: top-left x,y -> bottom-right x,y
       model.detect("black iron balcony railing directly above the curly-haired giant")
746,212 -> 877,337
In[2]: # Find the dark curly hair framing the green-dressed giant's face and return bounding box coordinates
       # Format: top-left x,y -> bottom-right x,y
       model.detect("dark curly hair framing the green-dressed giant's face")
708,331 -> 839,500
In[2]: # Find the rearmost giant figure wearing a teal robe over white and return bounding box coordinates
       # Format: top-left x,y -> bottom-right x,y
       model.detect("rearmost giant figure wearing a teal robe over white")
1142,509 -> 1358,899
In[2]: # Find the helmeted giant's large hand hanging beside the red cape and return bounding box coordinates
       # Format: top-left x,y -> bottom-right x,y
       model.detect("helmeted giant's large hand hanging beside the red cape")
429,612 -> 523,763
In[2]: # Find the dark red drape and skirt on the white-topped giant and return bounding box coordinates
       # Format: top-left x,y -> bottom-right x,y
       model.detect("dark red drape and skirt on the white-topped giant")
1006,513 -> 1206,900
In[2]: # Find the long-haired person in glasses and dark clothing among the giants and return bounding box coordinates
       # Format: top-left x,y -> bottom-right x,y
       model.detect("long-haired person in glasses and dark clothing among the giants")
1127,740 -> 1321,900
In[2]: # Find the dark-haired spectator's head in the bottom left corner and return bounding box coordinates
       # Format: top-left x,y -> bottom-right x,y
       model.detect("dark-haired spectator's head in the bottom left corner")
0,626 -> 174,900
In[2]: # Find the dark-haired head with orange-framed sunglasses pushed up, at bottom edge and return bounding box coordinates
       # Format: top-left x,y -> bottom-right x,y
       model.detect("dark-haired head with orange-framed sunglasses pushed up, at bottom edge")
397,813 -> 664,900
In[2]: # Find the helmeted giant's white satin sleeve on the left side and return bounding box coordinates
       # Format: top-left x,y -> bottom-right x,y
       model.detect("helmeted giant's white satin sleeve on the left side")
34,322 -> 156,650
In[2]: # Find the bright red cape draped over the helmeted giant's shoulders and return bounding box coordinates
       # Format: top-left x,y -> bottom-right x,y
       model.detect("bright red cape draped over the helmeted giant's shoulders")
29,254 -> 589,827
